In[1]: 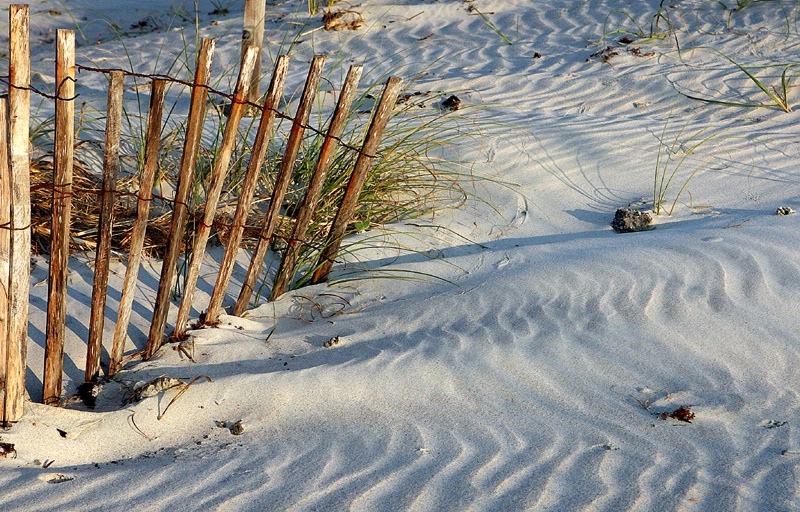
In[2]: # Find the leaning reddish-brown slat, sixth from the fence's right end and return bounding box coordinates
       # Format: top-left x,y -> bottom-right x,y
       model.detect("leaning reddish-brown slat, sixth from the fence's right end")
144,39 -> 214,359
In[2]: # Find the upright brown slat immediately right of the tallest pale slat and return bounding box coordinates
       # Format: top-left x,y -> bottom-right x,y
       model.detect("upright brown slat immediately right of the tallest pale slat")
43,30 -> 75,405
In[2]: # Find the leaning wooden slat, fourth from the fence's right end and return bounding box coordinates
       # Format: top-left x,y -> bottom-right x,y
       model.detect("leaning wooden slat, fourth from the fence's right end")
206,54 -> 289,324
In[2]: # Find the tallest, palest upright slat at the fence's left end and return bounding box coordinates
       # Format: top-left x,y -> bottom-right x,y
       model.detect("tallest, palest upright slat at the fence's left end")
2,5 -> 31,425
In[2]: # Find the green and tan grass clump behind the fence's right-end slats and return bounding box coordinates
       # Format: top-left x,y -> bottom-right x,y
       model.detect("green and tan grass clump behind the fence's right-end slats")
260,80 -> 480,287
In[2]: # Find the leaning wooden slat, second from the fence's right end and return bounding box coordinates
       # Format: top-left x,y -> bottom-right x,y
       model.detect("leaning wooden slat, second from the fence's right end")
270,66 -> 363,300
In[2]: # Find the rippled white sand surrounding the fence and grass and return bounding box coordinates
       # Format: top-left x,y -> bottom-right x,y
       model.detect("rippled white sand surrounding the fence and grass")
0,0 -> 800,511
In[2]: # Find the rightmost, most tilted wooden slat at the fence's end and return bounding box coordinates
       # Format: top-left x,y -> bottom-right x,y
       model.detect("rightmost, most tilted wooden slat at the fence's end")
311,77 -> 403,284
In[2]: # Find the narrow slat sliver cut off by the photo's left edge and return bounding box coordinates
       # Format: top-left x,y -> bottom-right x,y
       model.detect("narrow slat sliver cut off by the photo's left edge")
0,95 -> 11,427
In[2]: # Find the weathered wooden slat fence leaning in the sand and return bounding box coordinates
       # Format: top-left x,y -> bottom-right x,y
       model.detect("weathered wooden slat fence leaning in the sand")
0,5 -> 401,425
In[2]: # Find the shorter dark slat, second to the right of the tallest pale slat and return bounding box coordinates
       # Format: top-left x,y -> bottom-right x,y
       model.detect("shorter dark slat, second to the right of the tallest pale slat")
86,71 -> 125,382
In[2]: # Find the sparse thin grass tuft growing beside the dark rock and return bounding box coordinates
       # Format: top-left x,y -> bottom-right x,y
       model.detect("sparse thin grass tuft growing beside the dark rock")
653,119 -> 716,215
